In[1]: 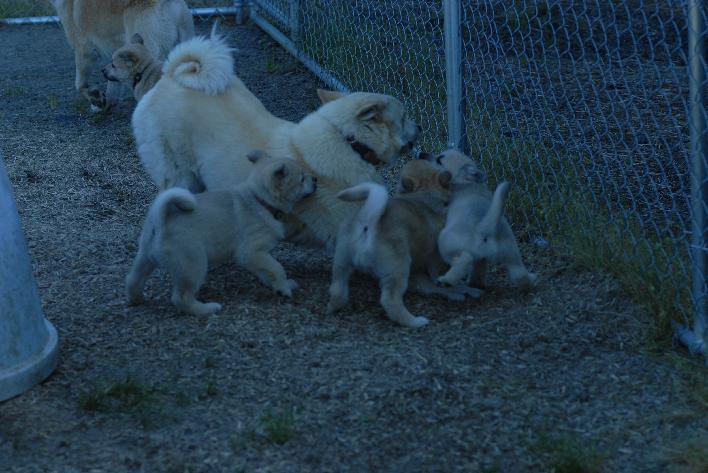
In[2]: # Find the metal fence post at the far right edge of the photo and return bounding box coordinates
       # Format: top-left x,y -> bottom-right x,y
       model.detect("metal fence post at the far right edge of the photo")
678,0 -> 708,362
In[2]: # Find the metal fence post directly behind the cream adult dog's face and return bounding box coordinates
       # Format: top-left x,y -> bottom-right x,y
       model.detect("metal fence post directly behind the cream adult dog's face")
443,0 -> 469,153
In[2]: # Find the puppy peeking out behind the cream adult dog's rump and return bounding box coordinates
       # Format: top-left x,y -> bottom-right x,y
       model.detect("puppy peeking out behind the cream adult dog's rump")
103,33 -> 162,102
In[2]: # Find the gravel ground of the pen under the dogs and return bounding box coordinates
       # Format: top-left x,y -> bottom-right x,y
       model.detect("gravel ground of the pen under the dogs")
0,19 -> 708,472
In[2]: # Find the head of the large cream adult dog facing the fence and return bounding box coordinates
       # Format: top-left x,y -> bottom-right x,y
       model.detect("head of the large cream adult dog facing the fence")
317,89 -> 420,166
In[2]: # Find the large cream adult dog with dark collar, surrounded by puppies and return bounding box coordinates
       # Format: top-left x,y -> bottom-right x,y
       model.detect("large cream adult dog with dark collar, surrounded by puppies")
132,35 -> 419,244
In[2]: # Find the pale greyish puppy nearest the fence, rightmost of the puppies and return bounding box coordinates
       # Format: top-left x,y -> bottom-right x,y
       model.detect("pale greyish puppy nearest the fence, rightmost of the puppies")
419,149 -> 538,289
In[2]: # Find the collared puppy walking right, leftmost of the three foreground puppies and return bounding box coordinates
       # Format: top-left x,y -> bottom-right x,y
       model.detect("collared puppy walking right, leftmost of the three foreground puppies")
126,152 -> 317,315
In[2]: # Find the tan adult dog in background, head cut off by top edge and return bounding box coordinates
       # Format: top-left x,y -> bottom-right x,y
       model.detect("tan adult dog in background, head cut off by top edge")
51,0 -> 194,110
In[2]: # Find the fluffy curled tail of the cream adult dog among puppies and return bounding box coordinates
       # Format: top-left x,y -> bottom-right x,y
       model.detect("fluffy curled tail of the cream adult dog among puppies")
162,25 -> 234,95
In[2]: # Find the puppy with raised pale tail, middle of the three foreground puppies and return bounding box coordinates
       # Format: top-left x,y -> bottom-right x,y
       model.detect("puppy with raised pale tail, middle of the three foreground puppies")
327,161 -> 479,328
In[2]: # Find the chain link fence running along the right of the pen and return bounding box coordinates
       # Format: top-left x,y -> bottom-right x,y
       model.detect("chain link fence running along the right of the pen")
0,0 -> 708,353
